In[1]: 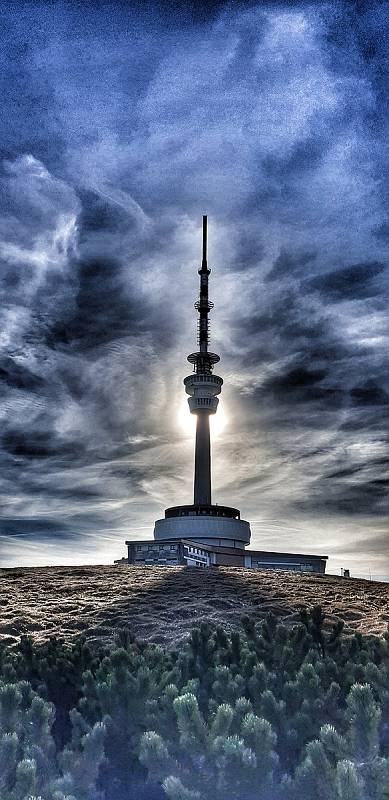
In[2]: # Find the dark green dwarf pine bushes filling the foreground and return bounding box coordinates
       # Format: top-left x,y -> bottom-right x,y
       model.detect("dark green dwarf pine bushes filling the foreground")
0,608 -> 389,800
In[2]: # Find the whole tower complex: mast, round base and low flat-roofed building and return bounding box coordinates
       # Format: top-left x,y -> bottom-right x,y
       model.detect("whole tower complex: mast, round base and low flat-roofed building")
121,217 -> 327,573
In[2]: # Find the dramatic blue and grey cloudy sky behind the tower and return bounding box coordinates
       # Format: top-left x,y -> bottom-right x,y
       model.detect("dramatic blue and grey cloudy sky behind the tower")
0,0 -> 389,577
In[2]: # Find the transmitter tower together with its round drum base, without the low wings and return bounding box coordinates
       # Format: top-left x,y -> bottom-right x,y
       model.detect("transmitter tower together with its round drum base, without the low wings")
154,216 -> 250,548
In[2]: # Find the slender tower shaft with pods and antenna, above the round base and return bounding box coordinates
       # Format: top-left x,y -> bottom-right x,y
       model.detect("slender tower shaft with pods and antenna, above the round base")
184,216 -> 223,506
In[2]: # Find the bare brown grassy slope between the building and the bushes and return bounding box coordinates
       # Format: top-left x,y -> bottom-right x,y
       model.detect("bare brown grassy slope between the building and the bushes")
0,566 -> 389,644
